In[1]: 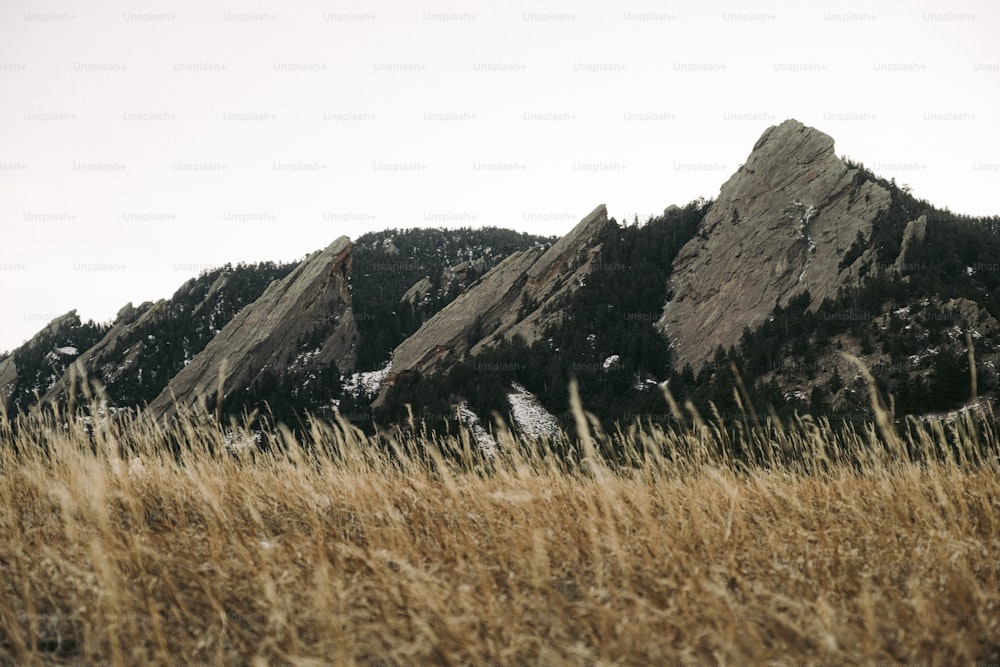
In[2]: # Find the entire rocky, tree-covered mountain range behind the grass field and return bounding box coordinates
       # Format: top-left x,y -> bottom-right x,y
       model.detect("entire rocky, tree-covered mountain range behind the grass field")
9,120 -> 1000,442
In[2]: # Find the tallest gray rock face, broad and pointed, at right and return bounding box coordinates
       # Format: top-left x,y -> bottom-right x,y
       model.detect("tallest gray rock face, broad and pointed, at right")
657,120 -> 890,370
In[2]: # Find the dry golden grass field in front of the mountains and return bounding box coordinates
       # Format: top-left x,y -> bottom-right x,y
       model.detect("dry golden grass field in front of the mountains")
0,384 -> 1000,665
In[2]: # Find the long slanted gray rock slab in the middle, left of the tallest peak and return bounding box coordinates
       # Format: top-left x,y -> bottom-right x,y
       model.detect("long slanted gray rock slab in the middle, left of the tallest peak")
374,204 -> 611,406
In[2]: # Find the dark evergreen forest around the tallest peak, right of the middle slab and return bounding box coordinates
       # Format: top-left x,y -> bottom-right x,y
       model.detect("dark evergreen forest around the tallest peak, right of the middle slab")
375,177 -> 1000,436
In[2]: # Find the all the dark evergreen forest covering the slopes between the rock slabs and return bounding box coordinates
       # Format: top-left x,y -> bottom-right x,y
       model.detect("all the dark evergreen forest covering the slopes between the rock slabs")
8,176 -> 1000,438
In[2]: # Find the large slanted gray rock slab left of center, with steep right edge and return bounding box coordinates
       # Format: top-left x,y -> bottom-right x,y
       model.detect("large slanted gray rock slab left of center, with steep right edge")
148,236 -> 358,419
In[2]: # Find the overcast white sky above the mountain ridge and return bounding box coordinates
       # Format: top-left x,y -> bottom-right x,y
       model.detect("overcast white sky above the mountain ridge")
0,0 -> 1000,350
